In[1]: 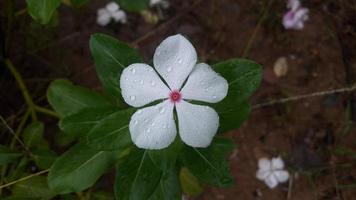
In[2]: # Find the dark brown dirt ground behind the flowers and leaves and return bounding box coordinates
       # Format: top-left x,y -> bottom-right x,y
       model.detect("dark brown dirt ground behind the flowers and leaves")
0,0 -> 356,200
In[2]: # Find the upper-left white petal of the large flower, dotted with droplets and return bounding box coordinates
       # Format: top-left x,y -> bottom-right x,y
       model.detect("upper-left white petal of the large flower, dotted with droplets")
120,63 -> 170,107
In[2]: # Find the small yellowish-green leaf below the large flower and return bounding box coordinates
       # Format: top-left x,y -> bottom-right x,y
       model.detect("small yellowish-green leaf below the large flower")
179,167 -> 203,197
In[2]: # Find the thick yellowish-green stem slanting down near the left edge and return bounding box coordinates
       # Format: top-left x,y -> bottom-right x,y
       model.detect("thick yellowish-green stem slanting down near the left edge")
5,59 -> 37,121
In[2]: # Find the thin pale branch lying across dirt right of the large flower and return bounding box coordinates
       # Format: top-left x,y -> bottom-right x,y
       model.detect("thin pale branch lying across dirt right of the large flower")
252,84 -> 356,109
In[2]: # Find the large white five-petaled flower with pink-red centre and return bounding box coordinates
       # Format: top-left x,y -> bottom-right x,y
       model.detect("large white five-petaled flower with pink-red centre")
120,34 -> 228,149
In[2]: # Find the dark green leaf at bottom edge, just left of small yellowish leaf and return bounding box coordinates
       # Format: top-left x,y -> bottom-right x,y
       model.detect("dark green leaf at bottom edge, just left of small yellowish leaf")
149,168 -> 182,200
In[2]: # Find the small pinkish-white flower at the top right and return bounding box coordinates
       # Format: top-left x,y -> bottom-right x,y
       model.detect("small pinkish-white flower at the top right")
283,0 -> 309,30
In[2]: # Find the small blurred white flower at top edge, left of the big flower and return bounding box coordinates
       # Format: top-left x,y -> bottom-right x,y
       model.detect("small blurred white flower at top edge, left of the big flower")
96,2 -> 127,26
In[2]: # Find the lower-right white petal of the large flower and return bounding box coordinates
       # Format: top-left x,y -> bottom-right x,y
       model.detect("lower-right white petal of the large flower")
176,101 -> 219,147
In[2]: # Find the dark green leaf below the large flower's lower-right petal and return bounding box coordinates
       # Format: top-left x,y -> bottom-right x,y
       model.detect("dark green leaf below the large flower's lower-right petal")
182,137 -> 235,187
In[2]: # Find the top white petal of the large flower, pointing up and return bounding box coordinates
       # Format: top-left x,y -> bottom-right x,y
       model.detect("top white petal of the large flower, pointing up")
153,34 -> 197,90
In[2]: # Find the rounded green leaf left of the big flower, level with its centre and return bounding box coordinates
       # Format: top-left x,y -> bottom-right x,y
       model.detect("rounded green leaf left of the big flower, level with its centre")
47,79 -> 111,117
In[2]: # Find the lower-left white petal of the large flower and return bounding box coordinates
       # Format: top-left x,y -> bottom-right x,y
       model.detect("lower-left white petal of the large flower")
129,100 -> 177,149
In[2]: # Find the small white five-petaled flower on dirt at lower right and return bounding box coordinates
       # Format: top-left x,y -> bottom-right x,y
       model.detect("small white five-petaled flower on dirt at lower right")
256,157 -> 289,189
